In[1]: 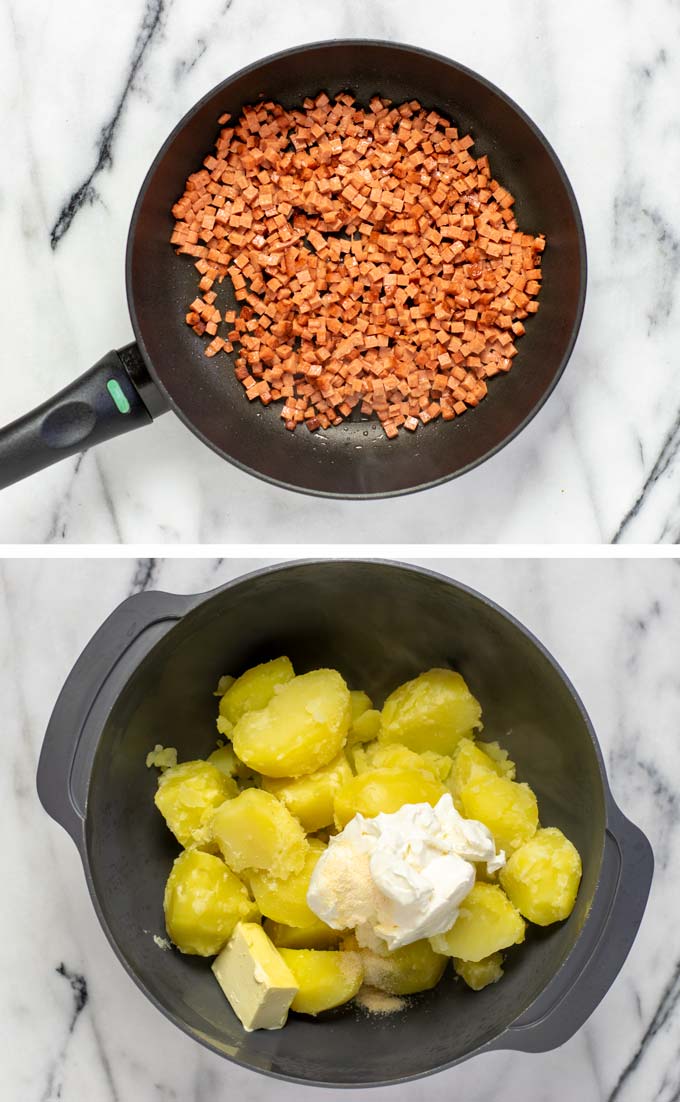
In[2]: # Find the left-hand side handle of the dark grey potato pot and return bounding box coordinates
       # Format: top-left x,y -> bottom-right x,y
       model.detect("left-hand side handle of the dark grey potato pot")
36,591 -> 197,850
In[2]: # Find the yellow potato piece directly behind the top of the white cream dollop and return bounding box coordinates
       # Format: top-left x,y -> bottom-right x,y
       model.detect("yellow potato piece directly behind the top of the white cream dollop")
335,769 -> 446,830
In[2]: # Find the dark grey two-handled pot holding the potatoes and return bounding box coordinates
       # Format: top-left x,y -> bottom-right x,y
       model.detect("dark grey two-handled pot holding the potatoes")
37,561 -> 654,1088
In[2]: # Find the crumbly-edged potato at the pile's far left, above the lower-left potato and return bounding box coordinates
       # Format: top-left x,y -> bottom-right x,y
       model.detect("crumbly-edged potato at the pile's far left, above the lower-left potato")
154,761 -> 238,846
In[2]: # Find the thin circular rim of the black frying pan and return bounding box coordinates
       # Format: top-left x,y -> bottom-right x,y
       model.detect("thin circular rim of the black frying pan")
125,37 -> 587,501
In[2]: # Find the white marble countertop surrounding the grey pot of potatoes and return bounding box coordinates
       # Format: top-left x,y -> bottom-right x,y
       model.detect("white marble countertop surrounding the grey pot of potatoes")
0,560 -> 680,1102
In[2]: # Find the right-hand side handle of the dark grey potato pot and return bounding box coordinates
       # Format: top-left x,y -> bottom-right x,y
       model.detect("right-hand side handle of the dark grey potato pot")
488,800 -> 654,1052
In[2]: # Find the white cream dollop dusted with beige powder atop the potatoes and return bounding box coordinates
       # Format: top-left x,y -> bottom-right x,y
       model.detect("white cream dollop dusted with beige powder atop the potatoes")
307,793 -> 505,950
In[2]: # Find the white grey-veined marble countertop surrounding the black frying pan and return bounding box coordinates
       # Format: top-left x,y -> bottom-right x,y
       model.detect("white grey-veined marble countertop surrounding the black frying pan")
0,0 -> 680,543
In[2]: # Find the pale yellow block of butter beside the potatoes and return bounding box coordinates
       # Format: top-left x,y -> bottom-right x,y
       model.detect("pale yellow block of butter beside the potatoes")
213,922 -> 298,1033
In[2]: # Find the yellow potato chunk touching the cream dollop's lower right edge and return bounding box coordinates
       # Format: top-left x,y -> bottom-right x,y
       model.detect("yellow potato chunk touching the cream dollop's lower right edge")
430,883 -> 526,962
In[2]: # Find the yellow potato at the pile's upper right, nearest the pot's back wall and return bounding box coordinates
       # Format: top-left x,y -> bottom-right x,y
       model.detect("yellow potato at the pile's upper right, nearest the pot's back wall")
379,669 -> 482,754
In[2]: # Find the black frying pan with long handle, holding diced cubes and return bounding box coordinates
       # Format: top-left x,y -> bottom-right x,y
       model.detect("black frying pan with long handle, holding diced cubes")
0,40 -> 586,498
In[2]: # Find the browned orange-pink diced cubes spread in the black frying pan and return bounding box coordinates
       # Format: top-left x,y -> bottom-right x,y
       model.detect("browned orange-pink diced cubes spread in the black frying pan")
171,93 -> 546,439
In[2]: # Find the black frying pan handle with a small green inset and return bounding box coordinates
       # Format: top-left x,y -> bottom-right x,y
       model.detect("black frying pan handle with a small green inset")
0,345 -> 164,489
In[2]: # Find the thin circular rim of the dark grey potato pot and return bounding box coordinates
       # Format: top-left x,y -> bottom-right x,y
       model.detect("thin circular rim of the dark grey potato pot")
78,555 -> 617,1090
